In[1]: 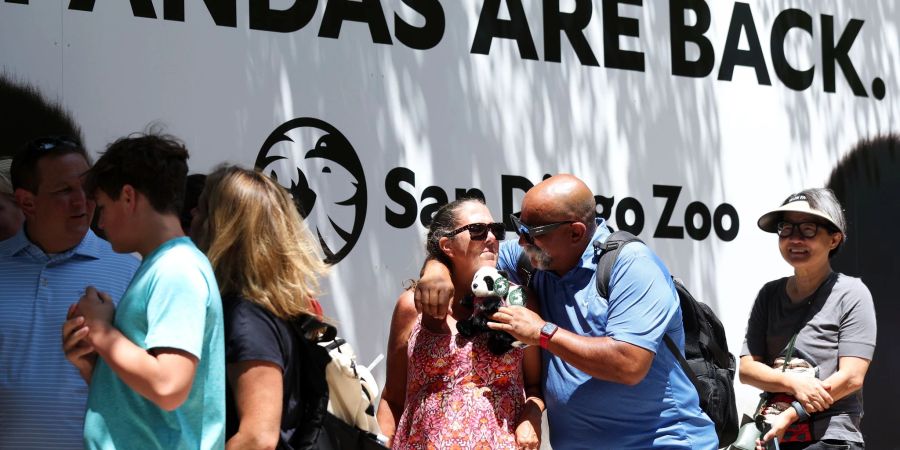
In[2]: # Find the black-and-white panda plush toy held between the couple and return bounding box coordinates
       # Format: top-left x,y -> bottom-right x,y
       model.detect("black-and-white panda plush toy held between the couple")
456,267 -> 525,355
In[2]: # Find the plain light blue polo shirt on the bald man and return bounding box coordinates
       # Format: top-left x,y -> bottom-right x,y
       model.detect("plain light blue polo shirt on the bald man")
500,219 -> 718,450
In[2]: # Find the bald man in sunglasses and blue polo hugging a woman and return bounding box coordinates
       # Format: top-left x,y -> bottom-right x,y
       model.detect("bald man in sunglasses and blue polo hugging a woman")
416,174 -> 718,450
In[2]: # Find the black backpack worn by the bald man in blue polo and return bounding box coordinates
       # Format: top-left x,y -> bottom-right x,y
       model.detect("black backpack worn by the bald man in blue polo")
594,231 -> 738,447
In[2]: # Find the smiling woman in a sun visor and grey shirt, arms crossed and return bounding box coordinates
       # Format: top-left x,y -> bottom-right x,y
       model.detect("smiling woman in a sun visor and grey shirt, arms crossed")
740,189 -> 875,450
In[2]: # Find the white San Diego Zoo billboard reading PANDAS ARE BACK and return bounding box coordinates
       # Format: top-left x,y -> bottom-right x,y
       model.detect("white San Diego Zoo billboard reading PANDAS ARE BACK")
0,0 -> 900,442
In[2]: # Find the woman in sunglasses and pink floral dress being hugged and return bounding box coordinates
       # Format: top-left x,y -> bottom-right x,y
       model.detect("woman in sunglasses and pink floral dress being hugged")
377,199 -> 544,449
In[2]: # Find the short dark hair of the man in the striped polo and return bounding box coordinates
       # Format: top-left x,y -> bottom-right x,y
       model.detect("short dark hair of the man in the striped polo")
9,136 -> 91,194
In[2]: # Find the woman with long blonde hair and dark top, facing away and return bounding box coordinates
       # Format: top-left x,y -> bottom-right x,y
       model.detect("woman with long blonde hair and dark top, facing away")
192,166 -> 327,449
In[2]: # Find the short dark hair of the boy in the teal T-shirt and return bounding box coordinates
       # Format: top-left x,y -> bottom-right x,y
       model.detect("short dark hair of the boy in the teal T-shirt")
85,132 -> 189,215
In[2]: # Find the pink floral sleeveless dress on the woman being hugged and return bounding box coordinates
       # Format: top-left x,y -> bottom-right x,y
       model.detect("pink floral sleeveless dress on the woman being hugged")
392,316 -> 525,450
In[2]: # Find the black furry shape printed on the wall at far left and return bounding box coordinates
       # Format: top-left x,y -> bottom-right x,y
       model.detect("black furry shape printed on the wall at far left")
0,71 -> 84,162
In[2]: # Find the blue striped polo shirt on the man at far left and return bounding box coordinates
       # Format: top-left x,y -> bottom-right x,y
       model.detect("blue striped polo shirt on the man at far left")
0,227 -> 139,450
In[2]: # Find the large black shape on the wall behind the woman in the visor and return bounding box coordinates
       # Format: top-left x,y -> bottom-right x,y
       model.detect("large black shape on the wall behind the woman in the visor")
828,134 -> 900,449
